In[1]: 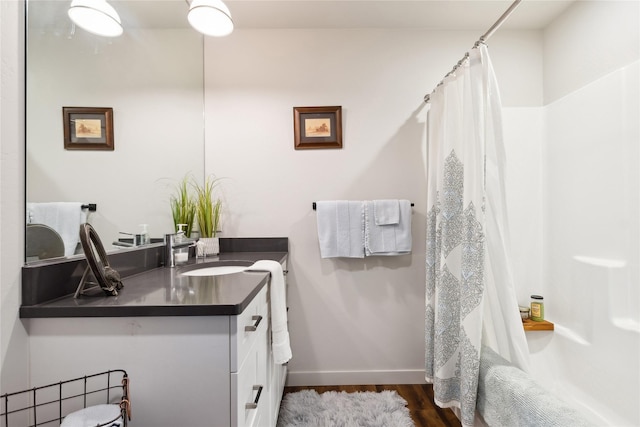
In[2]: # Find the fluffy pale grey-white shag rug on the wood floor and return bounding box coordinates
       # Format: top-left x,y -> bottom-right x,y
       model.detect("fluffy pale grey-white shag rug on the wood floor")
277,390 -> 414,427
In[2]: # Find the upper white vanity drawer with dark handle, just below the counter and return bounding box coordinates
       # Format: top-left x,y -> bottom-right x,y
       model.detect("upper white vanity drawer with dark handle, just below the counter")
230,286 -> 269,372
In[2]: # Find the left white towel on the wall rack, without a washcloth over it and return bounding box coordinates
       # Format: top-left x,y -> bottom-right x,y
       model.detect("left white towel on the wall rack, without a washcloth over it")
316,200 -> 364,258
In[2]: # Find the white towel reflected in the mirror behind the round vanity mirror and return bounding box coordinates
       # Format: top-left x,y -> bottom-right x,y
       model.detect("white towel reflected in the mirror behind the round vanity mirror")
27,202 -> 87,256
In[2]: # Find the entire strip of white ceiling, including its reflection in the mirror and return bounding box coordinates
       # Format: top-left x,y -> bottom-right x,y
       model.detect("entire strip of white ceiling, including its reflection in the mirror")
29,0 -> 574,32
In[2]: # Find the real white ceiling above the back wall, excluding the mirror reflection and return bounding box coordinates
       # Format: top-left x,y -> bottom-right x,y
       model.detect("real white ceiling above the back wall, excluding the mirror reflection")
227,0 -> 571,30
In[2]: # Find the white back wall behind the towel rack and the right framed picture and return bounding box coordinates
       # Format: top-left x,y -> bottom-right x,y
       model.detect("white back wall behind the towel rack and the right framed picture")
205,29 -> 542,384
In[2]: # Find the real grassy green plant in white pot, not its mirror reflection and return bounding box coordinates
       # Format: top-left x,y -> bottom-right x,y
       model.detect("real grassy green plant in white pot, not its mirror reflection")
193,176 -> 222,255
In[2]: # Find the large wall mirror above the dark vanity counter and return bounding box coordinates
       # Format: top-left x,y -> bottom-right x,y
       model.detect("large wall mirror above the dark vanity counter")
25,0 -> 204,262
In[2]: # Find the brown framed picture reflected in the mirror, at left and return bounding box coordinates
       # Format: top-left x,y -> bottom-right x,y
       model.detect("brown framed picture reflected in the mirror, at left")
62,107 -> 114,151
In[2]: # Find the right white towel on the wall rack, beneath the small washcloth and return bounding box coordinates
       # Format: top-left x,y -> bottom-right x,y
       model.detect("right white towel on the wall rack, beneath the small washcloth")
364,200 -> 412,256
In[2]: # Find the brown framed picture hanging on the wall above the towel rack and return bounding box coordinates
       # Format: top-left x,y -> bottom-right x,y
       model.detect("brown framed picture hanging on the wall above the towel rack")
293,107 -> 342,150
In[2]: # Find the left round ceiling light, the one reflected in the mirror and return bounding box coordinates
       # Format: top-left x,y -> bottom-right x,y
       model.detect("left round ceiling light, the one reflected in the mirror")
67,0 -> 122,37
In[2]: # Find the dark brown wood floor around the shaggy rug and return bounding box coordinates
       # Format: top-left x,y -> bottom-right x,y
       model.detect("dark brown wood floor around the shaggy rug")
284,384 -> 461,427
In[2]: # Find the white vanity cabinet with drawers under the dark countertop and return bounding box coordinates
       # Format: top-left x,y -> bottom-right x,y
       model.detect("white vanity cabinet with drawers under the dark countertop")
26,265 -> 287,427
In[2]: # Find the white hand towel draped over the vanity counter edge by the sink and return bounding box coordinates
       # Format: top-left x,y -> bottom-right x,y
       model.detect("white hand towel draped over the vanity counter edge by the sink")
248,260 -> 291,365
